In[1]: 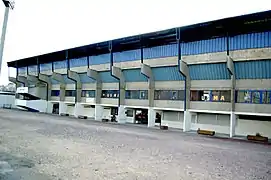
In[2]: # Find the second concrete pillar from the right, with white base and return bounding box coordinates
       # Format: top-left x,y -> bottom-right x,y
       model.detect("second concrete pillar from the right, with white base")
179,60 -> 192,132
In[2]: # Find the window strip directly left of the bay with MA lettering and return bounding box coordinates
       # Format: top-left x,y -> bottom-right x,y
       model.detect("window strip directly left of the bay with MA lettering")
154,90 -> 185,101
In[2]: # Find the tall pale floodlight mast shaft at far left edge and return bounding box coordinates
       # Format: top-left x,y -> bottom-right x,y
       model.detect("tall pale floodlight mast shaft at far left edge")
0,7 -> 9,76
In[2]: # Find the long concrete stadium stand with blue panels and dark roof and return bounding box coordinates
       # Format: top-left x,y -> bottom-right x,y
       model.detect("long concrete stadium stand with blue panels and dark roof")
8,11 -> 271,138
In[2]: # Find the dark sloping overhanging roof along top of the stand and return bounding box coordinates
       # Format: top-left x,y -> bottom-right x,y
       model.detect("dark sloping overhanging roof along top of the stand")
8,10 -> 271,67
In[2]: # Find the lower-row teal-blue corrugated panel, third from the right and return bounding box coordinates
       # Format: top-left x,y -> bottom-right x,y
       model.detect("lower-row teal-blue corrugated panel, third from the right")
152,66 -> 184,81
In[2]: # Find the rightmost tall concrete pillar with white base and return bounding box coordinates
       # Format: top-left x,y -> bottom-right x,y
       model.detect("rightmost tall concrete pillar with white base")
227,56 -> 236,138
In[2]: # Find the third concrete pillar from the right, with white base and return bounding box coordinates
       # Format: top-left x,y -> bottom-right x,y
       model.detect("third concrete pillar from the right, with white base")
141,63 -> 156,127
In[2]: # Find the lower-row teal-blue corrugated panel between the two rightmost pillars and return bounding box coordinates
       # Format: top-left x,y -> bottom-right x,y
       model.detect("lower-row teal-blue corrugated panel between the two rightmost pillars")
189,63 -> 230,80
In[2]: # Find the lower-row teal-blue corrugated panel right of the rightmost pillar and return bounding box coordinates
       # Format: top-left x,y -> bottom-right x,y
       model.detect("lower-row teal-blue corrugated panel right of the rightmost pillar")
234,60 -> 271,79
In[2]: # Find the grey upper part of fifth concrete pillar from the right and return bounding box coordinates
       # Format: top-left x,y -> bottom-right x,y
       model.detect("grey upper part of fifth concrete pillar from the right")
87,68 -> 102,104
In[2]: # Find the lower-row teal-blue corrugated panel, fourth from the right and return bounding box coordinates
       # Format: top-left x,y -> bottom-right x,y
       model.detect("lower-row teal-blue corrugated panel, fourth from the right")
122,69 -> 148,82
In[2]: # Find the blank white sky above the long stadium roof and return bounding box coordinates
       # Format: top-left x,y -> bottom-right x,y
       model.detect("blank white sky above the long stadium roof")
0,0 -> 271,84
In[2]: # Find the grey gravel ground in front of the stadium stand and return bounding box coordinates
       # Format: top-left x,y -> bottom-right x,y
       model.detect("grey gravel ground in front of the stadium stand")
0,109 -> 271,180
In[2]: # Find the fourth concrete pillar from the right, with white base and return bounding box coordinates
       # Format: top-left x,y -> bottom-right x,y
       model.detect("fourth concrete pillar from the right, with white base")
111,66 -> 126,123
